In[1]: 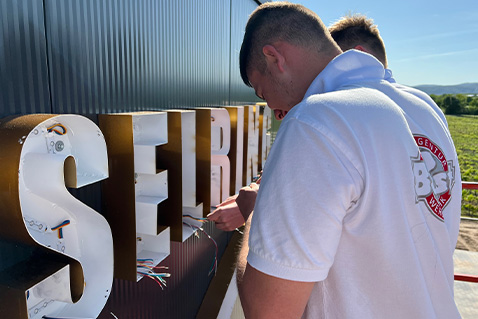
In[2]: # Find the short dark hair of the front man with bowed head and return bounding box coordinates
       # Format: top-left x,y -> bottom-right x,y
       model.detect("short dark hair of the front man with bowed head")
239,1 -> 339,86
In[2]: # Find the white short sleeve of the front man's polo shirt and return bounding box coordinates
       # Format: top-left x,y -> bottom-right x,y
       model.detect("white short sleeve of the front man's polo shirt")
247,118 -> 363,282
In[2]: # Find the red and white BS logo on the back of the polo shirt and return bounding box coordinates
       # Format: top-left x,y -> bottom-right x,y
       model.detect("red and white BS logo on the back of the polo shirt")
412,135 -> 455,221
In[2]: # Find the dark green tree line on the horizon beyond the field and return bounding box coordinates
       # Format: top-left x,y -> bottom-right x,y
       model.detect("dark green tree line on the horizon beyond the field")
430,94 -> 478,115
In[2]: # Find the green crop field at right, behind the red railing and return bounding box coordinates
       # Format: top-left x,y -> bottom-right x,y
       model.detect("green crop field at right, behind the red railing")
446,115 -> 478,218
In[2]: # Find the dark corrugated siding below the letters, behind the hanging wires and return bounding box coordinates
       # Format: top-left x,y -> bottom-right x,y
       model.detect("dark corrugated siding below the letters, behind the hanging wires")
98,223 -> 231,319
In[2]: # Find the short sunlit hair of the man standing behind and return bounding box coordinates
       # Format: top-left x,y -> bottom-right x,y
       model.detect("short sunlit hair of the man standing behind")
329,14 -> 387,67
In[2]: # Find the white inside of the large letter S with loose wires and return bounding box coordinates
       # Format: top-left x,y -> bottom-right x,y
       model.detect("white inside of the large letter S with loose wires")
19,115 -> 113,318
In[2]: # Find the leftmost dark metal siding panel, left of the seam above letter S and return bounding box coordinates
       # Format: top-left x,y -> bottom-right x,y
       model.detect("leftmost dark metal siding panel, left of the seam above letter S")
0,0 -> 51,117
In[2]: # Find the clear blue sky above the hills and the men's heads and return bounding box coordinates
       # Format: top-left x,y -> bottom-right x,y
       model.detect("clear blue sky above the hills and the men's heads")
282,0 -> 478,86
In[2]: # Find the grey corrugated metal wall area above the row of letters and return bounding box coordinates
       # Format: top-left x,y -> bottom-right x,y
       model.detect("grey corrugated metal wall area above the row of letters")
0,0 -> 257,117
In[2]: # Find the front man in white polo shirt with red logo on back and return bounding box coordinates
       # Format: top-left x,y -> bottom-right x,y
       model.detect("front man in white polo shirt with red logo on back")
238,2 -> 461,318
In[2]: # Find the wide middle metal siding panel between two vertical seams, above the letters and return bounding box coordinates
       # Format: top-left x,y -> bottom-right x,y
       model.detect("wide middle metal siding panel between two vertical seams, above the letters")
45,0 -> 230,114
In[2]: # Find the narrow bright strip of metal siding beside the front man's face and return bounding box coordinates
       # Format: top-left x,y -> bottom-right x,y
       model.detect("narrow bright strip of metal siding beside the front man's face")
230,0 -> 261,105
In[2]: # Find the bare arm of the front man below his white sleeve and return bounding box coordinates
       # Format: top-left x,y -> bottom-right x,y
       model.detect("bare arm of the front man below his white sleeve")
237,215 -> 315,319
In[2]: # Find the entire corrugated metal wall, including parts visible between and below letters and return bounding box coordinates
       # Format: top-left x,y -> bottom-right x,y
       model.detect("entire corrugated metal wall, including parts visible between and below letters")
0,0 -> 257,319
